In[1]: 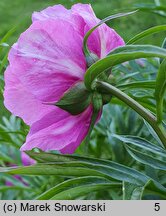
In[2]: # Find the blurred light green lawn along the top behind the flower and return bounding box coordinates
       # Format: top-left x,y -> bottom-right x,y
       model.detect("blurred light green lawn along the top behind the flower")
0,0 -> 166,45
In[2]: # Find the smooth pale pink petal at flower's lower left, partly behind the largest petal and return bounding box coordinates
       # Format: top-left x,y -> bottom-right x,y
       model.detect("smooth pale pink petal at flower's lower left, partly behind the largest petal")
4,66 -> 55,125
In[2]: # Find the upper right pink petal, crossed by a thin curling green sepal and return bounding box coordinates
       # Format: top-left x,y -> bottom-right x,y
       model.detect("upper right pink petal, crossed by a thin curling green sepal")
71,4 -> 125,58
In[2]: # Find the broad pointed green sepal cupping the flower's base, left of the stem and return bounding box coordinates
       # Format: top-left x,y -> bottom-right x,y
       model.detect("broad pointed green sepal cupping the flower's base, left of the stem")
55,82 -> 91,115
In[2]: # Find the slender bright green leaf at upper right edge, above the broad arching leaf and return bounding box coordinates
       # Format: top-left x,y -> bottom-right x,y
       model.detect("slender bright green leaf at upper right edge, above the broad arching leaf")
126,25 -> 166,44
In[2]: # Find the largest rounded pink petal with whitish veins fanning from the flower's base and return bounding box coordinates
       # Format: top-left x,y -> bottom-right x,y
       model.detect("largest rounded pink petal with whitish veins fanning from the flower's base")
9,20 -> 86,102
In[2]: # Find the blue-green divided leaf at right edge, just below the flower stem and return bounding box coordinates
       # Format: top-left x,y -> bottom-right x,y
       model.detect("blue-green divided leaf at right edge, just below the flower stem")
113,135 -> 166,170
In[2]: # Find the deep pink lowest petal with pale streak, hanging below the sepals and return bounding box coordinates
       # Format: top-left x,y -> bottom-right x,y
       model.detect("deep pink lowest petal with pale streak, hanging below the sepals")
21,106 -> 92,153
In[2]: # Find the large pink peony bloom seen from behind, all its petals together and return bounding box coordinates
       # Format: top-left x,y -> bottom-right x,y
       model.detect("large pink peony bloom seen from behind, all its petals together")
4,4 -> 124,153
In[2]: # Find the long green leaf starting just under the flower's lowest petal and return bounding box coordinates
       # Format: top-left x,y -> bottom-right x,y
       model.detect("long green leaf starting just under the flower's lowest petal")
14,151 -> 166,185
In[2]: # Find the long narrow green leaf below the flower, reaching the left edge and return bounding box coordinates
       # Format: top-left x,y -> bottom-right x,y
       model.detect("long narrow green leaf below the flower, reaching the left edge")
0,161 -> 144,185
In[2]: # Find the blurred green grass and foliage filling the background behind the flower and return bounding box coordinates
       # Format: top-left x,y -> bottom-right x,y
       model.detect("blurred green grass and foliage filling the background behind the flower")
0,0 -> 166,199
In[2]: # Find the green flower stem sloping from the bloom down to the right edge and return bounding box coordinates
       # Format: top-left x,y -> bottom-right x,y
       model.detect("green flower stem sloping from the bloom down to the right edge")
96,81 -> 166,148
